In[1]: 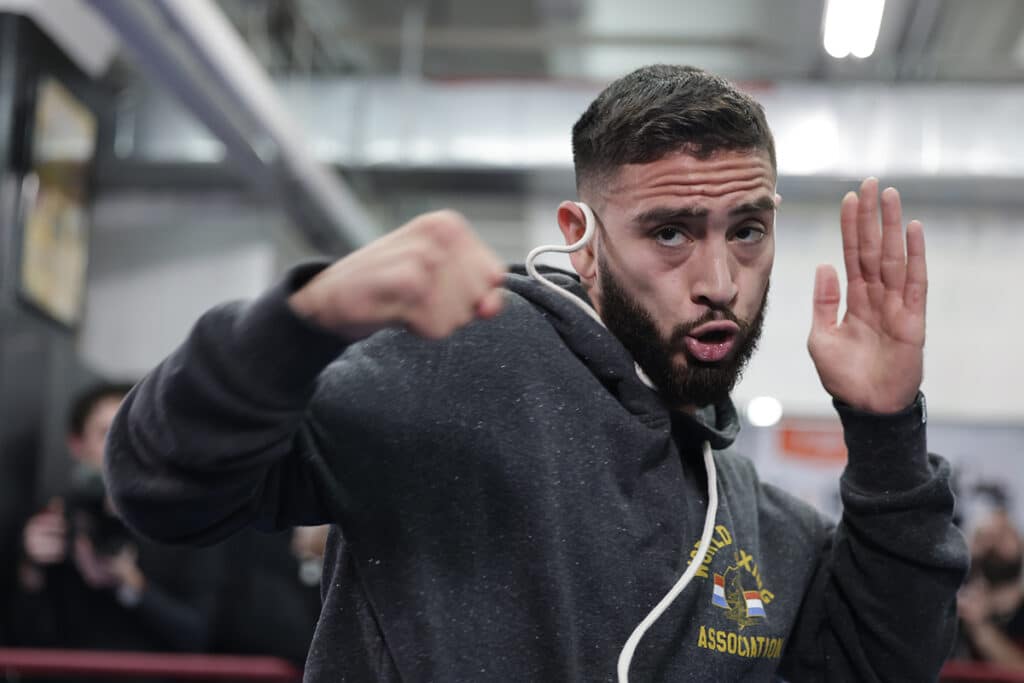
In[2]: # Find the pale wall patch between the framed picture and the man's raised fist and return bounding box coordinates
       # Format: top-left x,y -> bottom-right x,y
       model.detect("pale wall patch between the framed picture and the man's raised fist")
79,194 -> 288,379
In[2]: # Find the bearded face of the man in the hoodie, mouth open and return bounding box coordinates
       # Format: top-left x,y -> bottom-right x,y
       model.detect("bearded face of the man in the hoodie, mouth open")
585,152 -> 777,408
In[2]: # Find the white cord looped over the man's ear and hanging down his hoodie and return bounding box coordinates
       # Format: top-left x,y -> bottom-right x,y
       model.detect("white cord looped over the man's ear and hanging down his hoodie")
526,202 -> 718,683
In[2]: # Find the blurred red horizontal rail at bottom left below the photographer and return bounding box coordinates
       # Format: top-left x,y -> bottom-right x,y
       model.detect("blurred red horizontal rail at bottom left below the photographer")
0,647 -> 302,683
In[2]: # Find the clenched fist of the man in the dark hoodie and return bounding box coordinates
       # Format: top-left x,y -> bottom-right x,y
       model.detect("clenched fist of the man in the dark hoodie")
289,211 -> 505,341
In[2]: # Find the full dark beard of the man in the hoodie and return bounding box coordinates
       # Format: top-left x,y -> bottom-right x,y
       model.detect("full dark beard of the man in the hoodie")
598,256 -> 768,407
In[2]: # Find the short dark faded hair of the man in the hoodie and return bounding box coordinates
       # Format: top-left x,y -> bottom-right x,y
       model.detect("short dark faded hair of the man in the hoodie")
572,65 -> 776,193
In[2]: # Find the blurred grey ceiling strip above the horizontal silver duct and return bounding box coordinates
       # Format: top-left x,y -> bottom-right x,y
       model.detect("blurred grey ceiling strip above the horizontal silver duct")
218,0 -> 1024,82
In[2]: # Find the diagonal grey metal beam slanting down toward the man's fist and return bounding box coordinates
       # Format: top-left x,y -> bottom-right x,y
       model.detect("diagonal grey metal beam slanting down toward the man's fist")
80,0 -> 379,253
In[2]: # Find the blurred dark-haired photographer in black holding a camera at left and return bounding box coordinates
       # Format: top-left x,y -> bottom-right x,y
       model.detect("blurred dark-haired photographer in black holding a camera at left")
12,383 -> 221,667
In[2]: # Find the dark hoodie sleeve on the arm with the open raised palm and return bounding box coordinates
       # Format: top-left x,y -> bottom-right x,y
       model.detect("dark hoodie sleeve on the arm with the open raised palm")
779,394 -> 968,683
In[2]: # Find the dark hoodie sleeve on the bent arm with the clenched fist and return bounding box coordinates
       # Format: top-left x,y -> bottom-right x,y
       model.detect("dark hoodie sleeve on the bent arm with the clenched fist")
105,265 -> 352,544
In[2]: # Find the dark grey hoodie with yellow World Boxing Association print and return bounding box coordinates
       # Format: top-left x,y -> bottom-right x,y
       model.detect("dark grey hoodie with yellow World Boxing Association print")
108,266 -> 967,683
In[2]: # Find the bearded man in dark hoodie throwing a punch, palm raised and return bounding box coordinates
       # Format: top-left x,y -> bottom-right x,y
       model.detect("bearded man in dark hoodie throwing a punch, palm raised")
109,67 -> 967,681
